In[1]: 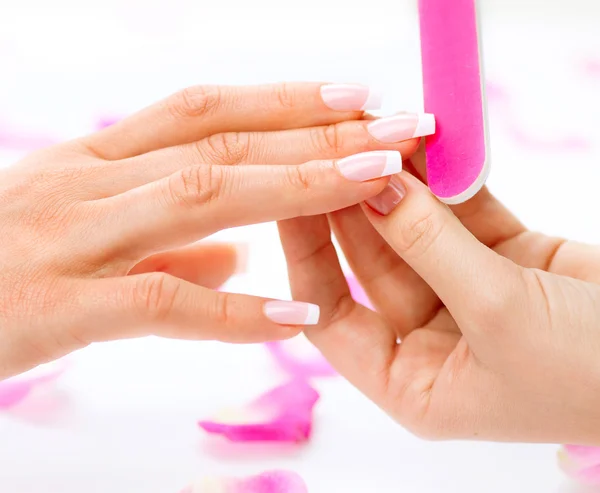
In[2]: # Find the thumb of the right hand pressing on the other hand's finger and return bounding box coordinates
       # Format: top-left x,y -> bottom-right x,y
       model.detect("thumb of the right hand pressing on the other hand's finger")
363,172 -> 523,318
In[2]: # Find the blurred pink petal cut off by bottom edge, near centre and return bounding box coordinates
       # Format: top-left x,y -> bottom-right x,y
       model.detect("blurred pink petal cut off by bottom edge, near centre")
180,471 -> 308,493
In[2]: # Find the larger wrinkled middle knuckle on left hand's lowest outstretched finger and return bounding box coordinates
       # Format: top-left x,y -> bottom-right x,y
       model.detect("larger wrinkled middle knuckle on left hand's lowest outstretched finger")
133,272 -> 179,321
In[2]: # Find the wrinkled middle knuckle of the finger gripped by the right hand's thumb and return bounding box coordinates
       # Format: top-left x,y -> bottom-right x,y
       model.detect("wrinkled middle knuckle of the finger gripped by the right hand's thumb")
168,165 -> 224,207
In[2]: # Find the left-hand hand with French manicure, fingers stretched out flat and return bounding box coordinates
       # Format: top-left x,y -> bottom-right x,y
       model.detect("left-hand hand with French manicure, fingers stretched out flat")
0,84 -> 418,379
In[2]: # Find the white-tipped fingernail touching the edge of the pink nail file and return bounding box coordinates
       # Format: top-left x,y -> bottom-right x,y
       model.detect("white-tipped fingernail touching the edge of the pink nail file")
367,113 -> 435,144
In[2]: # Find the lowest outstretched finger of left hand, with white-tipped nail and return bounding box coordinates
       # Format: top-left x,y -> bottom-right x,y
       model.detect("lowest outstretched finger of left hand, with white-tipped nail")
76,272 -> 319,343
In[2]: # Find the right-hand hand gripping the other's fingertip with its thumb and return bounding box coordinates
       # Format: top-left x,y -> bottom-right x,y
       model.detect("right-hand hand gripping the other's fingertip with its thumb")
280,149 -> 600,445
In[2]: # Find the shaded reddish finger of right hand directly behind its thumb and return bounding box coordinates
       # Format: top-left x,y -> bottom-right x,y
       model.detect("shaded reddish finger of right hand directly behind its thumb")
330,205 -> 440,337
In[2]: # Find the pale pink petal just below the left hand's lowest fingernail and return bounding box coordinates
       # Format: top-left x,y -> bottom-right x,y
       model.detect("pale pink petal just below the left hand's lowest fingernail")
266,337 -> 337,379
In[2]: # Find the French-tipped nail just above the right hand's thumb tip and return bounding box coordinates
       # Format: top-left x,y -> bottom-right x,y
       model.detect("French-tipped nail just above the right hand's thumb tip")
337,151 -> 402,181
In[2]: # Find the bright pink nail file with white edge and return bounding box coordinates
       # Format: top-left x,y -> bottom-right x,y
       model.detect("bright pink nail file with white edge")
419,0 -> 490,204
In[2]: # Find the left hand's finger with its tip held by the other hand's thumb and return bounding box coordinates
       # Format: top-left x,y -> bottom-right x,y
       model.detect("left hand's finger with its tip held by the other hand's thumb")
96,151 -> 401,258
